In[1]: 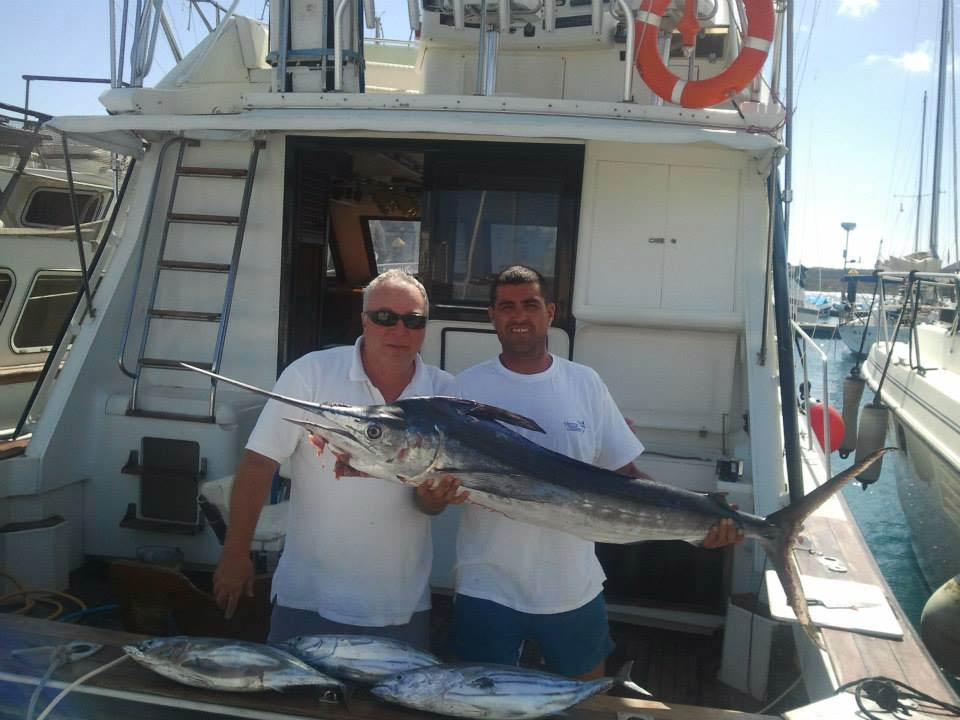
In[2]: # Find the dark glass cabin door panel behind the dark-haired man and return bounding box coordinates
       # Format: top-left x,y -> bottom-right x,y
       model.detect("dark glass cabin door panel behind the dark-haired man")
420,146 -> 583,326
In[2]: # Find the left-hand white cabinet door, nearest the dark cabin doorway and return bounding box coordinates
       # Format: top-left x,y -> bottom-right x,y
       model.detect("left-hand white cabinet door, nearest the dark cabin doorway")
586,160 -> 670,308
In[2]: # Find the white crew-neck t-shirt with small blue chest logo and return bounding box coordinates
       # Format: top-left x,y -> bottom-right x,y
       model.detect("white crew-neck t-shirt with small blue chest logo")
451,355 -> 643,614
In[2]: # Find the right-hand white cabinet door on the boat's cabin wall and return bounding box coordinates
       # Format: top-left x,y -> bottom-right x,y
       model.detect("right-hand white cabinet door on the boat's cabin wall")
661,165 -> 740,312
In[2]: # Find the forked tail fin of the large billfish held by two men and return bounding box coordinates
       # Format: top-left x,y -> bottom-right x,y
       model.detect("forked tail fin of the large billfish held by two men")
757,447 -> 896,648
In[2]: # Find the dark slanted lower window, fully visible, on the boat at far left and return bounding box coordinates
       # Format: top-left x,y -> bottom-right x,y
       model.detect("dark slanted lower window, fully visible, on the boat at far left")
11,271 -> 81,353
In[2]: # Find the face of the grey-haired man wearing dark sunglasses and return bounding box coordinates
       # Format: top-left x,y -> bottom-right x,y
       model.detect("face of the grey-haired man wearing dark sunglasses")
362,282 -> 426,368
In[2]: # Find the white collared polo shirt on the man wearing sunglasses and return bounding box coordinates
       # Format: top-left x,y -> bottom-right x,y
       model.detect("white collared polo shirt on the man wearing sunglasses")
247,338 -> 452,627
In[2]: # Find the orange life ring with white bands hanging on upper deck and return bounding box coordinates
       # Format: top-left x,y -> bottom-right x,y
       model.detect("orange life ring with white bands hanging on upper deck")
636,0 -> 774,108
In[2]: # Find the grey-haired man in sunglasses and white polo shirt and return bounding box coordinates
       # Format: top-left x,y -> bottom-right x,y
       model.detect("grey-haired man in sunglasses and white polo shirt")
214,270 -> 465,649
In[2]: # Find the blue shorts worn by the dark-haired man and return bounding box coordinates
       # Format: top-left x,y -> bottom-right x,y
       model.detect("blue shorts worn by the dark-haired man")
450,593 -> 613,677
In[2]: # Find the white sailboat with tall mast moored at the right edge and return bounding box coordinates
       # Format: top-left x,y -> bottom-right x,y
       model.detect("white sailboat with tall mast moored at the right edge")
857,2 -> 960,590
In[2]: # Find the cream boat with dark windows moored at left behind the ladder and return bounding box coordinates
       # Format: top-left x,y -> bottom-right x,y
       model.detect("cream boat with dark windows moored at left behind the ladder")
0,105 -> 120,439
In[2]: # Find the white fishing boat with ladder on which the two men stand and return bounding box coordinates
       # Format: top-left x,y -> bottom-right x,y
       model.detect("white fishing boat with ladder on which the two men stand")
0,0 -> 952,715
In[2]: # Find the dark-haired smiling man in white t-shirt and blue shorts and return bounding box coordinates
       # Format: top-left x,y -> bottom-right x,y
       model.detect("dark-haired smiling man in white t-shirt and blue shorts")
451,265 -> 742,678
